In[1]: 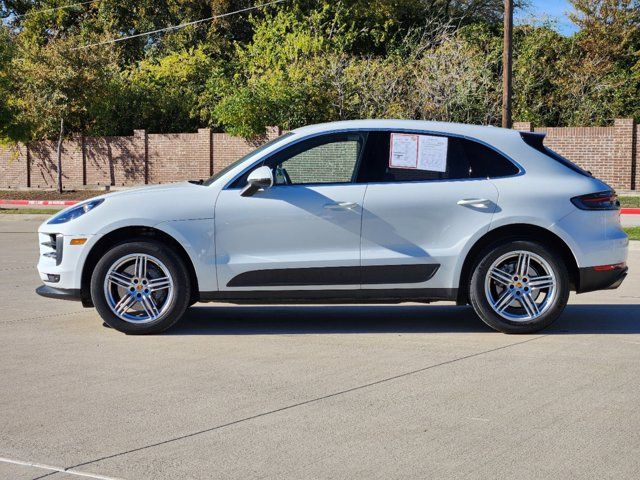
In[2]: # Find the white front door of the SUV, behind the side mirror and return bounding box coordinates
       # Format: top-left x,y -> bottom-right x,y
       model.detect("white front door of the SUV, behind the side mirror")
215,129 -> 366,291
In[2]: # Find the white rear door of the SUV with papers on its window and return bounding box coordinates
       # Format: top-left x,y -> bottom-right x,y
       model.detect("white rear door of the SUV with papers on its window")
358,132 -> 510,290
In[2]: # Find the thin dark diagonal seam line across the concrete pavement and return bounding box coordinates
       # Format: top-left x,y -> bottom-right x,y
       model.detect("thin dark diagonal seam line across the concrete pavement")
65,334 -> 550,471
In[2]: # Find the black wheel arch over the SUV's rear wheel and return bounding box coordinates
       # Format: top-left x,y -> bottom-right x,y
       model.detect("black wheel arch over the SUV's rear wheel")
457,223 -> 580,305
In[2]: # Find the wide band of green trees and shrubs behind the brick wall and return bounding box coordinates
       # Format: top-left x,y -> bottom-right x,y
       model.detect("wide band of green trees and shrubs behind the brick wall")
0,0 -> 640,141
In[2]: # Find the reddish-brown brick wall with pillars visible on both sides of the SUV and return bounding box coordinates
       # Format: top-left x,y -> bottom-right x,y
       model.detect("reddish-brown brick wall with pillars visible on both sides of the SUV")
0,119 -> 640,190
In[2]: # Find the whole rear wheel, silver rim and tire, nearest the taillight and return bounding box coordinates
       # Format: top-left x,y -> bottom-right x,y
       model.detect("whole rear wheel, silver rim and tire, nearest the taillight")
469,240 -> 569,333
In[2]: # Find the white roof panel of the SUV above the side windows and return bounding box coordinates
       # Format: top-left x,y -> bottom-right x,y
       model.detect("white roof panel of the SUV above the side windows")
293,120 -> 520,143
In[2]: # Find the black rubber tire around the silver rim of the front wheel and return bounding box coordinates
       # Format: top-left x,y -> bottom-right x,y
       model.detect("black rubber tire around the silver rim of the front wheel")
91,239 -> 191,335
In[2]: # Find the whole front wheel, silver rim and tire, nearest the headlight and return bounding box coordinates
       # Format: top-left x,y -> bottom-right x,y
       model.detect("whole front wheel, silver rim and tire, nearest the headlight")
91,240 -> 191,334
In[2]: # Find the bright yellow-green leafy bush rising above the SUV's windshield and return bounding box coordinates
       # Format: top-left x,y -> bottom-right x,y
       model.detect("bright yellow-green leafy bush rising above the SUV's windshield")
213,11 -> 339,137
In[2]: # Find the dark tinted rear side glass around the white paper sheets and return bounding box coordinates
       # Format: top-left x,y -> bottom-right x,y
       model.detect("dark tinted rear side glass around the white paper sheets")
357,132 -> 519,183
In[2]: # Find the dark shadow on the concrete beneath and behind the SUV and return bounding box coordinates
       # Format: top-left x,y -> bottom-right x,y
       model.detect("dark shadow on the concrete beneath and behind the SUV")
166,304 -> 640,335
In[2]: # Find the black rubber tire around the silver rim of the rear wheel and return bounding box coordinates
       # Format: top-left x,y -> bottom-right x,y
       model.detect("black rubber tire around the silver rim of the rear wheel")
469,240 -> 570,333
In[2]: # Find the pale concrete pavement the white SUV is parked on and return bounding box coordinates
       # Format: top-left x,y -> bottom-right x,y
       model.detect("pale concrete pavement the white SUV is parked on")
0,215 -> 640,480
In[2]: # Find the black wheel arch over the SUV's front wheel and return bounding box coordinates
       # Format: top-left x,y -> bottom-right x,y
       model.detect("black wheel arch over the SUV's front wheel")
80,225 -> 199,306
